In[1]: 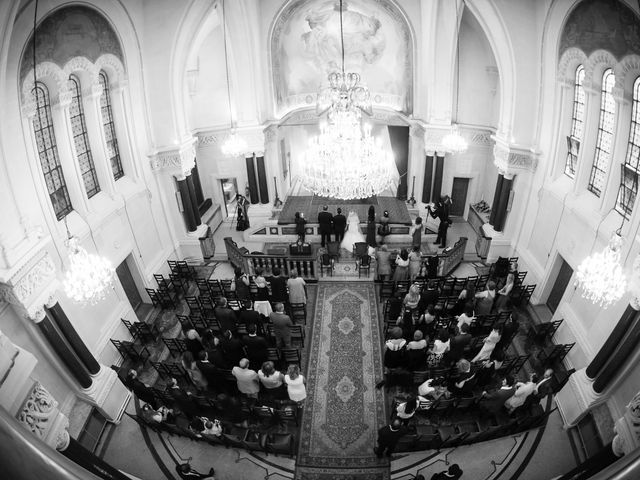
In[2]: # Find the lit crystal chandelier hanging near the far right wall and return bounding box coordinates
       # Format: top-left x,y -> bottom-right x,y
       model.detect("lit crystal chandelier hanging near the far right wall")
576,231 -> 627,308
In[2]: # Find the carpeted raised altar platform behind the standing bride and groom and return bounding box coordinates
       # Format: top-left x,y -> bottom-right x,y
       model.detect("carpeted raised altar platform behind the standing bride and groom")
278,195 -> 411,225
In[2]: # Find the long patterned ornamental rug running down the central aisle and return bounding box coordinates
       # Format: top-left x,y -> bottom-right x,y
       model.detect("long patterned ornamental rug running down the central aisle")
296,282 -> 389,480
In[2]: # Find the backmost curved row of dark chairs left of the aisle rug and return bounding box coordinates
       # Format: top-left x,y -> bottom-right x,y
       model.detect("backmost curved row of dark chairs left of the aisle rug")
127,413 -> 295,456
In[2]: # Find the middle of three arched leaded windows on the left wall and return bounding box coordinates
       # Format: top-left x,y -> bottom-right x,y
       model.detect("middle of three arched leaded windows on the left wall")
69,75 -> 100,198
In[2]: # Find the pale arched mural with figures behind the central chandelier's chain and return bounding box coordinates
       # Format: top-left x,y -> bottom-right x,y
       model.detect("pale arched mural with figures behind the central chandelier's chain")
271,0 -> 413,114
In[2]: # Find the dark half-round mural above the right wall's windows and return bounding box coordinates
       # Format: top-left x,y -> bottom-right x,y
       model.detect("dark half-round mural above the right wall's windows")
558,0 -> 640,60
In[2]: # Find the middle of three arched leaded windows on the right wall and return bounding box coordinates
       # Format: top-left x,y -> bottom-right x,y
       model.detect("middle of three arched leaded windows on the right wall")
587,68 -> 616,197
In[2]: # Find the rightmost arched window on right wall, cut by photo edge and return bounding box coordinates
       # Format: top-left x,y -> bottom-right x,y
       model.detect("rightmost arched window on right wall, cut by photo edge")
616,77 -> 640,218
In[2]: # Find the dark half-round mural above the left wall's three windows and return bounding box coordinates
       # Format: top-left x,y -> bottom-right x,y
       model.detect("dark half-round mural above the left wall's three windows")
20,6 -> 124,84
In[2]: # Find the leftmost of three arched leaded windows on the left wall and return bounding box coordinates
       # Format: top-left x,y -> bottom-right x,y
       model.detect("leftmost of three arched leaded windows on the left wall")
33,82 -> 73,220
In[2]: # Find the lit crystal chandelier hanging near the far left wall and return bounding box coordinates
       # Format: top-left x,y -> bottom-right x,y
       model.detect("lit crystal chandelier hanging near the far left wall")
63,236 -> 114,305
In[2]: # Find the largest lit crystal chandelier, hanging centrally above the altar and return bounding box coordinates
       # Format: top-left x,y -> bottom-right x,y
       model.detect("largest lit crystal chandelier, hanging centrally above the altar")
302,0 -> 394,200
